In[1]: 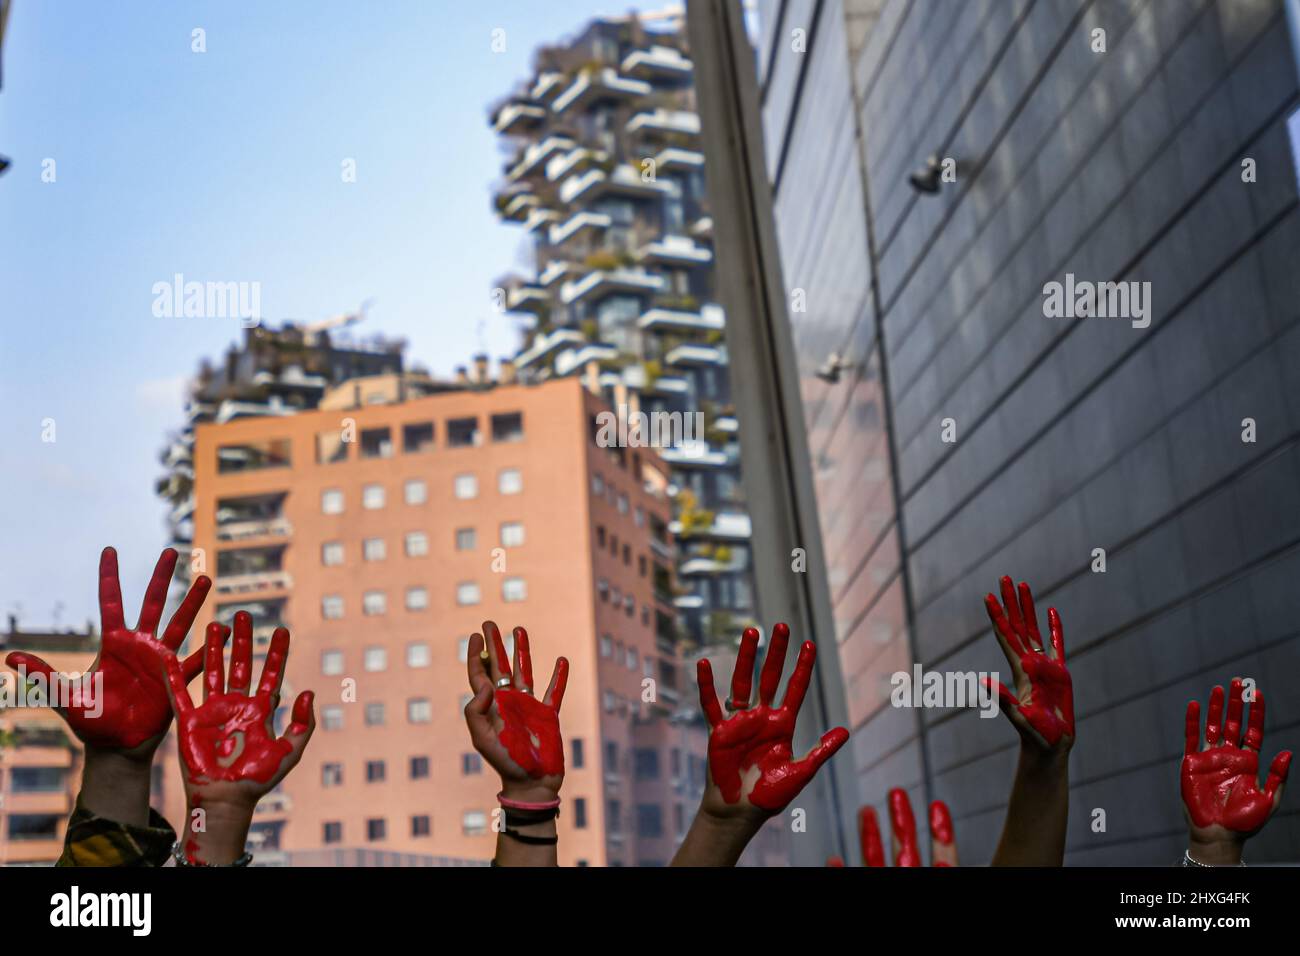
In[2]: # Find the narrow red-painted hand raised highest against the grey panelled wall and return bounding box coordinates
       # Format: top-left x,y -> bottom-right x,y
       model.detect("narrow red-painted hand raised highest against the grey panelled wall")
984,576 -> 1074,748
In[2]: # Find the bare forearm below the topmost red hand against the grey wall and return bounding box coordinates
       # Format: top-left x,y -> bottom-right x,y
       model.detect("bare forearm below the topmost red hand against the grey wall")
993,744 -> 1070,866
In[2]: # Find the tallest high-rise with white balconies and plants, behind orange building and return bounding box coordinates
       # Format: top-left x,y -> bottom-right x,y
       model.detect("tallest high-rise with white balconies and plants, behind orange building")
490,14 -> 754,643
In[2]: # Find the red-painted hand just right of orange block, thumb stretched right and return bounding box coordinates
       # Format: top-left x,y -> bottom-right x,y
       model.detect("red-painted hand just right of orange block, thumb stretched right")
697,624 -> 849,813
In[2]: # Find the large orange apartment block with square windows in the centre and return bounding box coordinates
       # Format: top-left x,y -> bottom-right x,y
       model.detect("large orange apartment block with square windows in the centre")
160,375 -> 706,866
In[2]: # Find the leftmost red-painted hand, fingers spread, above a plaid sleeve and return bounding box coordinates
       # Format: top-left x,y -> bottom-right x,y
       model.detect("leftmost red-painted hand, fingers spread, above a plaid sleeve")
5,548 -> 212,752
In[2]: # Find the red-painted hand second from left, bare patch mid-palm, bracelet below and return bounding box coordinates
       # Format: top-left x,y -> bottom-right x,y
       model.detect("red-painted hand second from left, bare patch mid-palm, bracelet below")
168,611 -> 313,803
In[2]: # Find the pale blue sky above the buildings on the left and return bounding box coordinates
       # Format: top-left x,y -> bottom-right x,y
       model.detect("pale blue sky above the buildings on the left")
0,0 -> 686,627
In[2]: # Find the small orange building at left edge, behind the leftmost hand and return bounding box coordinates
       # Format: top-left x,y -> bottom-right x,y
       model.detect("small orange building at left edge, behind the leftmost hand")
0,618 -> 99,866
